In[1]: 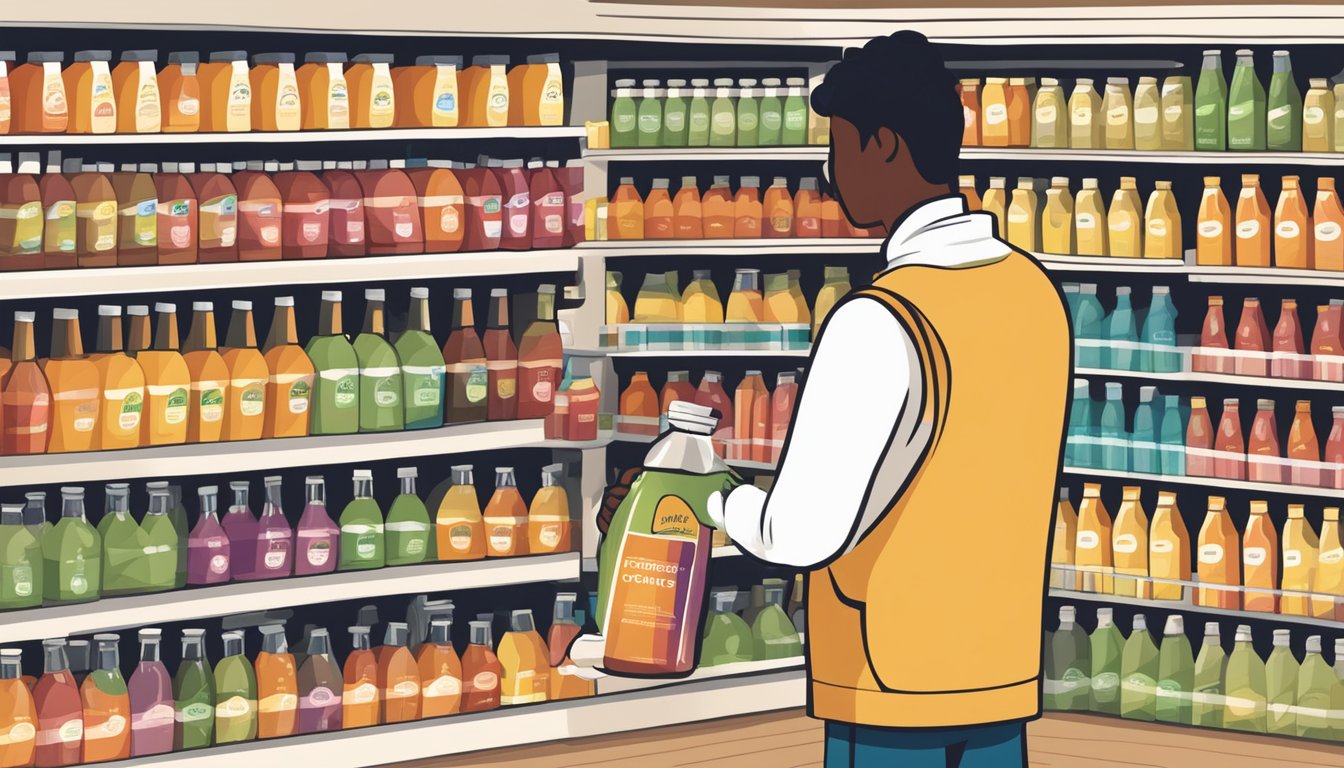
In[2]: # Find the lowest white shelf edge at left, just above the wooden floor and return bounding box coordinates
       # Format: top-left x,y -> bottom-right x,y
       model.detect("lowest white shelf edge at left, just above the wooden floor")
97,668 -> 808,768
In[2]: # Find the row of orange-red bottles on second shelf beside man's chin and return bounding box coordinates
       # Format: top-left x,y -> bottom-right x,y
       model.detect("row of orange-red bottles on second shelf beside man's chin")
587,176 -> 878,241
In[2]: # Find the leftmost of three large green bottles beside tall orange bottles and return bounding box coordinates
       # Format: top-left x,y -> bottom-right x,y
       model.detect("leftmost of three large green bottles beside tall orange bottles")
304,291 -> 359,434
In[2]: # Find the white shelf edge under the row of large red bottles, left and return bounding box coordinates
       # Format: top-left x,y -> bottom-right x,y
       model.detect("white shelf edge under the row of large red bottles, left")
0,249 -> 579,300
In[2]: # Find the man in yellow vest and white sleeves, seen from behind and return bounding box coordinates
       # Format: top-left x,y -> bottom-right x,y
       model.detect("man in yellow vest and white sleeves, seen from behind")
710,32 -> 1071,768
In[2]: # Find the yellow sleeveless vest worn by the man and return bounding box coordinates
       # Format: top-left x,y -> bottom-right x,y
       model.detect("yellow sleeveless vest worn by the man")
808,252 -> 1071,728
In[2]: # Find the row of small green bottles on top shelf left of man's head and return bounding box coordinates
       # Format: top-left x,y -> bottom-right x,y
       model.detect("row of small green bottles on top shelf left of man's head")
607,77 -> 829,149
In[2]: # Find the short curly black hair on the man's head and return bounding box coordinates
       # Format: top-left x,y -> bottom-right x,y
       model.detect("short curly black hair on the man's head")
812,30 -> 965,184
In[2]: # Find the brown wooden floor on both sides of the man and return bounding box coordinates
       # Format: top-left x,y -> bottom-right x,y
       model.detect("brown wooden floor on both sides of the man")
395,710 -> 1344,768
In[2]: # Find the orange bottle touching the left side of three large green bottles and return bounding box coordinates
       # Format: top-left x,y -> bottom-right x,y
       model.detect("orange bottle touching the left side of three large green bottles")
262,296 -> 316,437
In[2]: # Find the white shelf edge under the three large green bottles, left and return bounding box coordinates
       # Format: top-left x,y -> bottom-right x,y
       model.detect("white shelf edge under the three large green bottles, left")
0,418 -> 543,488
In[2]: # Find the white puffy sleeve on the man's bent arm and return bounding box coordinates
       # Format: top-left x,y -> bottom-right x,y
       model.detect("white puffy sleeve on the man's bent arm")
711,297 -> 931,568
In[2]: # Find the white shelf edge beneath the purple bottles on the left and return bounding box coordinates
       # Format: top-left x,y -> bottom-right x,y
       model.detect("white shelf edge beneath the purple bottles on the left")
0,553 -> 579,644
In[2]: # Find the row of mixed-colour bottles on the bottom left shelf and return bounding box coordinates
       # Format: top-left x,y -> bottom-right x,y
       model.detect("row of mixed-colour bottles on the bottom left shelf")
0,593 -> 594,768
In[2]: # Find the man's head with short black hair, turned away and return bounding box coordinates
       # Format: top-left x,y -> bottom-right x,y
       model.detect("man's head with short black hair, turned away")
812,31 -> 964,227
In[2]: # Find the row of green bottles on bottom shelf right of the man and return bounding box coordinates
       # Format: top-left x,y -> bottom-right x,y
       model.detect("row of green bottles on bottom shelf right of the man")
1043,605 -> 1344,741
